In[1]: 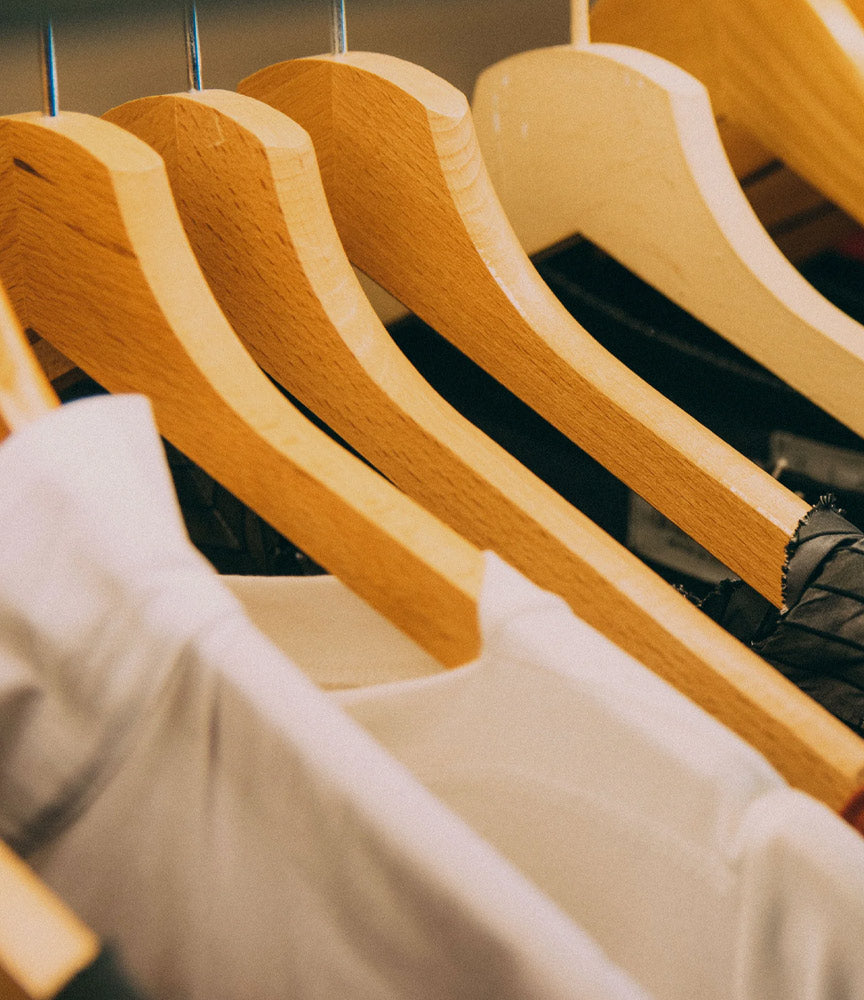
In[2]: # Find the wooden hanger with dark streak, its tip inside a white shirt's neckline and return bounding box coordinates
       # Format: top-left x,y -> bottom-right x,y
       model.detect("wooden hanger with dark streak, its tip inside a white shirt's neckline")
0,114 -> 483,665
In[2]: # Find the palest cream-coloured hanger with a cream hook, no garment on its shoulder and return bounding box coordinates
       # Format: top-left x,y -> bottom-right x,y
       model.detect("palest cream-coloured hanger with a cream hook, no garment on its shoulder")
473,0 -> 864,452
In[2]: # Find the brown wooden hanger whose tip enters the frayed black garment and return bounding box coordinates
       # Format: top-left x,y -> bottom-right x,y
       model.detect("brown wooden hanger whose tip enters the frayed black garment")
240,52 -> 805,604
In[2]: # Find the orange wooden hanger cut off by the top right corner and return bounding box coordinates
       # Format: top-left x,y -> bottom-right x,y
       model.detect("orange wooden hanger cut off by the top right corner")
591,0 -> 864,234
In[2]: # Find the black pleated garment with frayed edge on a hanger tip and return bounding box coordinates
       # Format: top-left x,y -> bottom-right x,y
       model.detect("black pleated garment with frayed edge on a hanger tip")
700,501 -> 864,736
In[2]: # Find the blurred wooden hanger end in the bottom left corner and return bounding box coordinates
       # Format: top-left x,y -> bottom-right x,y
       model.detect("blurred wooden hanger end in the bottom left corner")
0,841 -> 99,1000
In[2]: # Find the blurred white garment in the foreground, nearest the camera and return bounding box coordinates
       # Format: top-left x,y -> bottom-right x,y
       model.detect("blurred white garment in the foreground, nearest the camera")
0,397 -> 644,1000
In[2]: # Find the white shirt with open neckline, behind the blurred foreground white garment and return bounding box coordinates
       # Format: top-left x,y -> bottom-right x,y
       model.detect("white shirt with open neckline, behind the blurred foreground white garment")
229,556 -> 864,1000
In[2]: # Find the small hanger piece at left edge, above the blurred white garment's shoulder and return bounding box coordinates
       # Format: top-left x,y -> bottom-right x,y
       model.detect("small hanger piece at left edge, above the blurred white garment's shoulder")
0,285 -> 58,440
